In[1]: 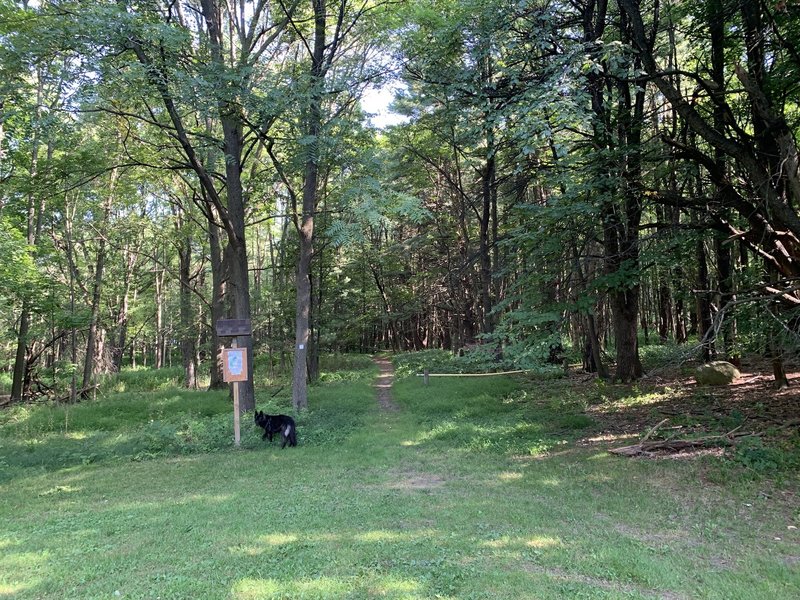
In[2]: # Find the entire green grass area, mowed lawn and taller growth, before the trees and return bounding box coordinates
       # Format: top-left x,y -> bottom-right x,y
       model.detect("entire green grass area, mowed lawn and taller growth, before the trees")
0,358 -> 800,600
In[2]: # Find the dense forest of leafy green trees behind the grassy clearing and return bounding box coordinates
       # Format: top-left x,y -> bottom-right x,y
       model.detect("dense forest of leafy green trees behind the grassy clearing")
0,0 -> 800,409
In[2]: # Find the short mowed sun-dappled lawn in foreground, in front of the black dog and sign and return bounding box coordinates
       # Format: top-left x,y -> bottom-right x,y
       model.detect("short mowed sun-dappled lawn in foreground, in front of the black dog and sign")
6,452 -> 798,600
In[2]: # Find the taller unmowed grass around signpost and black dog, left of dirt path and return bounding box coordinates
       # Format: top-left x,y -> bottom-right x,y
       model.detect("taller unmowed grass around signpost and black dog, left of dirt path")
0,356 -> 382,476
